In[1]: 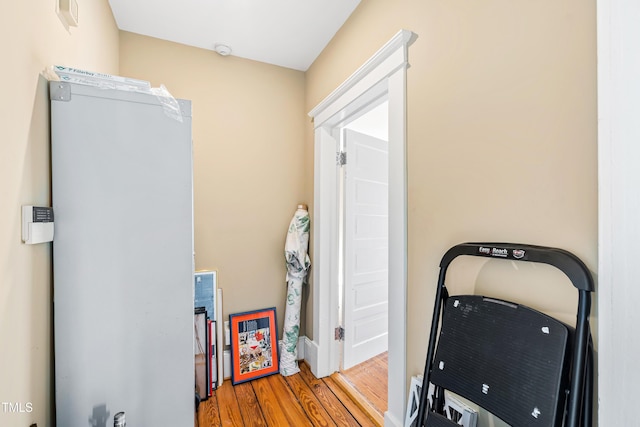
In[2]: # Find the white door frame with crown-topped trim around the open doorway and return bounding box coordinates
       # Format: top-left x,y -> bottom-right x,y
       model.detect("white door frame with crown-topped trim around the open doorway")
305,30 -> 417,427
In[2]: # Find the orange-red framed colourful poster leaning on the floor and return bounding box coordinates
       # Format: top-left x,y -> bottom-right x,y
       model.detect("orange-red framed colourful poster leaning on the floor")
229,307 -> 280,385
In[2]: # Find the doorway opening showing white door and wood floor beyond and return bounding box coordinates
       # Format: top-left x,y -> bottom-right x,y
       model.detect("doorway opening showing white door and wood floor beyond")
336,101 -> 389,425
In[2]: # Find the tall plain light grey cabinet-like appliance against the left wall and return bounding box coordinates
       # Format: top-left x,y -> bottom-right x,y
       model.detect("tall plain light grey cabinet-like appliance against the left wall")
50,82 -> 194,427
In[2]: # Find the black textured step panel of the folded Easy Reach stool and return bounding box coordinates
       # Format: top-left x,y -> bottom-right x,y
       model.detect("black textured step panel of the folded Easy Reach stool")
430,295 -> 572,427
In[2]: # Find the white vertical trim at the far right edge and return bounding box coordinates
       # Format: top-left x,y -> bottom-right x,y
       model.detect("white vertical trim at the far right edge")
592,0 -> 640,426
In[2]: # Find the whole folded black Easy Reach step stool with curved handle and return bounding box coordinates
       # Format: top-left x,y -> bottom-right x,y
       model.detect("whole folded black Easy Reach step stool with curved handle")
417,243 -> 594,427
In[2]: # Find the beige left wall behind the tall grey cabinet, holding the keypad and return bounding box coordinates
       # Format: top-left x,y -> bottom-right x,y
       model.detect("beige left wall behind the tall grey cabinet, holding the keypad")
0,0 -> 118,427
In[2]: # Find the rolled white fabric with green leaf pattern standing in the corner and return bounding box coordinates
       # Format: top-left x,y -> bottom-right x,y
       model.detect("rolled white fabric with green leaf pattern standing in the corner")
279,205 -> 311,376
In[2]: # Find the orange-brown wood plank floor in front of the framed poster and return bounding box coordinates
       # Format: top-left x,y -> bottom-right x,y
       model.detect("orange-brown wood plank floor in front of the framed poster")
195,362 -> 386,427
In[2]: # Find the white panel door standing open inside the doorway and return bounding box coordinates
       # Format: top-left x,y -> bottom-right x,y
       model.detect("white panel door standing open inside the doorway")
342,129 -> 389,369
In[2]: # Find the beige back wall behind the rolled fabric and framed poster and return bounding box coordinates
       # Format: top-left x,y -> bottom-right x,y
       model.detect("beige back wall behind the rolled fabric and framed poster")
120,32 -> 308,333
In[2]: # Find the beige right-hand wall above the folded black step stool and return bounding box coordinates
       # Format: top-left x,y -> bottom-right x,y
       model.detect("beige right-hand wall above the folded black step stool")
305,0 -> 597,402
